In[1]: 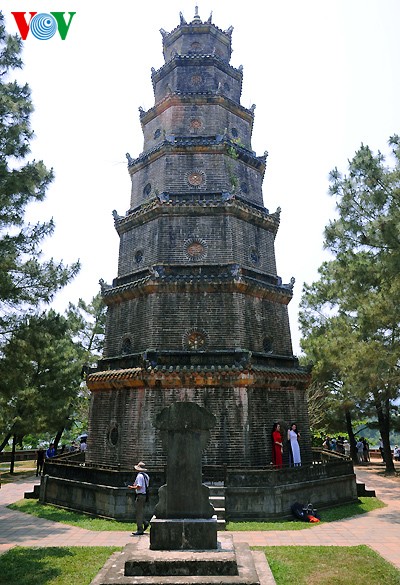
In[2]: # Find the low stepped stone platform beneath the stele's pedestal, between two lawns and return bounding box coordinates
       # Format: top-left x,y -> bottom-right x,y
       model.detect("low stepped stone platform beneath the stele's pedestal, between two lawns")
90,535 -> 275,585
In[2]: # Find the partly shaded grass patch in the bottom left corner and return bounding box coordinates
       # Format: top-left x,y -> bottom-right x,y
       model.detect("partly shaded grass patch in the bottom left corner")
0,546 -> 121,585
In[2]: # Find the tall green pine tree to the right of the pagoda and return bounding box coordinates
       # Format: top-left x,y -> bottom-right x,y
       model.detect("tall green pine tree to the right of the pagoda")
301,136 -> 400,471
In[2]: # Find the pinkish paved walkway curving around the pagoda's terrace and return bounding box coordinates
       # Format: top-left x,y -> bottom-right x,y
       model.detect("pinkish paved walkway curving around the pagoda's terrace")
0,467 -> 400,569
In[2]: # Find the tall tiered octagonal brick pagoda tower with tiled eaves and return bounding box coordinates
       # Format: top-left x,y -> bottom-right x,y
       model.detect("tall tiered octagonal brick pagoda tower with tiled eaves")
87,9 -> 311,467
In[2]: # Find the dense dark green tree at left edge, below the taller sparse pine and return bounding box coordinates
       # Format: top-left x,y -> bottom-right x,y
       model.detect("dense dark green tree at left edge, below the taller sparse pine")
0,310 -> 82,460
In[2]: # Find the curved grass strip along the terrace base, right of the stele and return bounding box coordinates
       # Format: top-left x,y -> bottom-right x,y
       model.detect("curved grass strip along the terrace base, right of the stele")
227,498 -> 386,531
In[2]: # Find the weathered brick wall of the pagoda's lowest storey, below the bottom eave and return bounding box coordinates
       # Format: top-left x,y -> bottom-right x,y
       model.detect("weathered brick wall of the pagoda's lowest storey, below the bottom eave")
87,384 -> 311,467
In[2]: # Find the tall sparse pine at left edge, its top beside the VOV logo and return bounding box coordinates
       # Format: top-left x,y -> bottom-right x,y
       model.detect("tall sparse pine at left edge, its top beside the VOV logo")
0,12 -> 79,343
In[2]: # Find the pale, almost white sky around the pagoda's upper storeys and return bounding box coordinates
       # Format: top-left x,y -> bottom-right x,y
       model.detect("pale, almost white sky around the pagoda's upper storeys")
2,0 -> 400,353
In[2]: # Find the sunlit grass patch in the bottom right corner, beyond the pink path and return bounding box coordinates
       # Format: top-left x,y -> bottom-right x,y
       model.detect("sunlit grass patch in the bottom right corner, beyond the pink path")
260,545 -> 400,585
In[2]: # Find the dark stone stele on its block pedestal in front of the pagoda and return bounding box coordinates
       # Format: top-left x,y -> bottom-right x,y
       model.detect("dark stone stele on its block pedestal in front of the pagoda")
150,402 -> 217,550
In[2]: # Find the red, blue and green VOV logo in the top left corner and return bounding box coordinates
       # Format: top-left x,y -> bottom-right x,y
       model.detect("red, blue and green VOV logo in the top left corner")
11,12 -> 76,41
